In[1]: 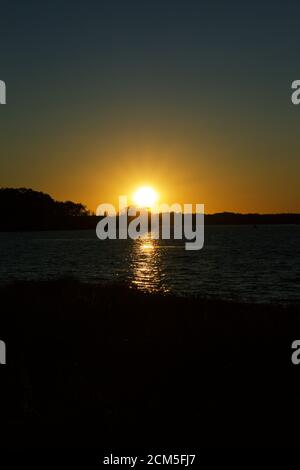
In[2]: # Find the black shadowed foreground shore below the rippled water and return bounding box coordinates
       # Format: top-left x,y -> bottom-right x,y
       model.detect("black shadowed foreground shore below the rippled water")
0,281 -> 300,450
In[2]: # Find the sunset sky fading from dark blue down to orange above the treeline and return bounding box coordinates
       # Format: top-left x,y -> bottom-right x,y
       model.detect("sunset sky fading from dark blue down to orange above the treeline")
0,0 -> 300,213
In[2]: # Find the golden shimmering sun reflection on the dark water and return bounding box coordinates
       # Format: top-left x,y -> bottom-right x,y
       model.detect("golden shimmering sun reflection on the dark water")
130,234 -> 168,292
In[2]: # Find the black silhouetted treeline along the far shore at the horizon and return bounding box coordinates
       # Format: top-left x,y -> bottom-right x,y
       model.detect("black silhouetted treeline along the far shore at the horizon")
0,188 -> 300,231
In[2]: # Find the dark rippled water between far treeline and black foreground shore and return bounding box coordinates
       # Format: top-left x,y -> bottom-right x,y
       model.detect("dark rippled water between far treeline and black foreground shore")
0,225 -> 300,302
